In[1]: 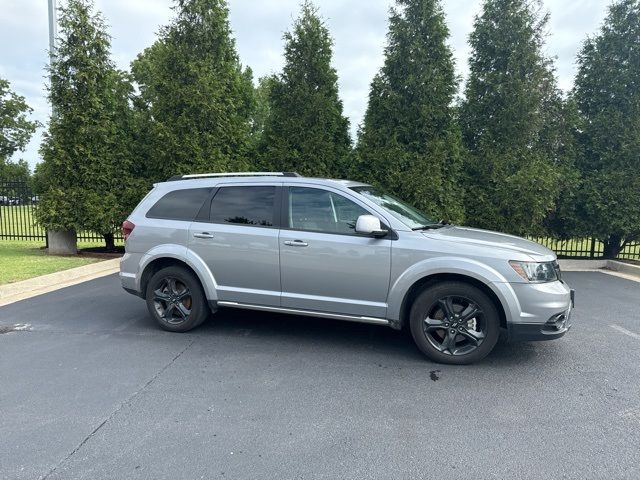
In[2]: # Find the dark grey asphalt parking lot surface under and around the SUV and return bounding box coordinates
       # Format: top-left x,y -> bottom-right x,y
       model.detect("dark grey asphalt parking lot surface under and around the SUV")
0,272 -> 640,480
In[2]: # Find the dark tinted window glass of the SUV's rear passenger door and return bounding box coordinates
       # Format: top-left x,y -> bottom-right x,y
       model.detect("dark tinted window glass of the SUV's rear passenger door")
210,187 -> 276,227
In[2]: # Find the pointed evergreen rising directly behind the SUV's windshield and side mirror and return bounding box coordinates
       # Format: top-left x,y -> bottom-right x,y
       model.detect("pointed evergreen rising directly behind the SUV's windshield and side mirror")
355,0 -> 464,221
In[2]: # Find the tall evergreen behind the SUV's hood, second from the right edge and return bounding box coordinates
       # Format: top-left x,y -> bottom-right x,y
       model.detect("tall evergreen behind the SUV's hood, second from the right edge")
461,0 -> 566,234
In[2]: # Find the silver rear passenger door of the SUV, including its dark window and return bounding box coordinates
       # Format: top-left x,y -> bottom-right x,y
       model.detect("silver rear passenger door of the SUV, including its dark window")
189,183 -> 281,306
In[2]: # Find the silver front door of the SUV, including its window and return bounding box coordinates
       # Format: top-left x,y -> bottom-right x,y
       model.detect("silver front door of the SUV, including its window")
280,185 -> 391,318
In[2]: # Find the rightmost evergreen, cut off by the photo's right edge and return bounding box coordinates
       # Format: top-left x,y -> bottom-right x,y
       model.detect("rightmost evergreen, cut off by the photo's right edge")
565,0 -> 640,258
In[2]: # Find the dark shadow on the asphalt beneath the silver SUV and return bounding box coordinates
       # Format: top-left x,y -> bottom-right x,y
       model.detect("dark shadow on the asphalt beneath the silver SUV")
182,309 -> 537,367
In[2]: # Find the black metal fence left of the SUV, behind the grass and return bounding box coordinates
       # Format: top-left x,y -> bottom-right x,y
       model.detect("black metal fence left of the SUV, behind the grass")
0,180 -> 122,243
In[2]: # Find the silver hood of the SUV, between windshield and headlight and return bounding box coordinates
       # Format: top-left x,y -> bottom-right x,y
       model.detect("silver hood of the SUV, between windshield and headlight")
423,226 -> 555,260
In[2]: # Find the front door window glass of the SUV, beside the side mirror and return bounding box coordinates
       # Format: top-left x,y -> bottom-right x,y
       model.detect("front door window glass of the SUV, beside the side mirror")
289,187 -> 369,234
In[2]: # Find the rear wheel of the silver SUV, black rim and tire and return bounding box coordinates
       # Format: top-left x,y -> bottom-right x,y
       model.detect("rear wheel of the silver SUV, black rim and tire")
145,266 -> 211,332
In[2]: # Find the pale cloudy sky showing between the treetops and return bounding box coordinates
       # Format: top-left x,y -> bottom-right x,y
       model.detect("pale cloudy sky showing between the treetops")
0,0 -> 611,167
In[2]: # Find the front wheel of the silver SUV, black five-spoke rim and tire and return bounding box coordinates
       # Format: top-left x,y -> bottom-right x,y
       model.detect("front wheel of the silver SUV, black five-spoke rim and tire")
409,282 -> 500,365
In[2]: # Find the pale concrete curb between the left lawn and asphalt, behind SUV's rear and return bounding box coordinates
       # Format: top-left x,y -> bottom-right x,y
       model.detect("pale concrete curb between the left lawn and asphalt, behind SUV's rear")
0,258 -> 120,306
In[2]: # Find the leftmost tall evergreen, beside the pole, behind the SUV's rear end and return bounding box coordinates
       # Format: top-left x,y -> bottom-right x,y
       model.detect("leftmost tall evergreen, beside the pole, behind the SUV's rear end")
36,0 -> 131,248
